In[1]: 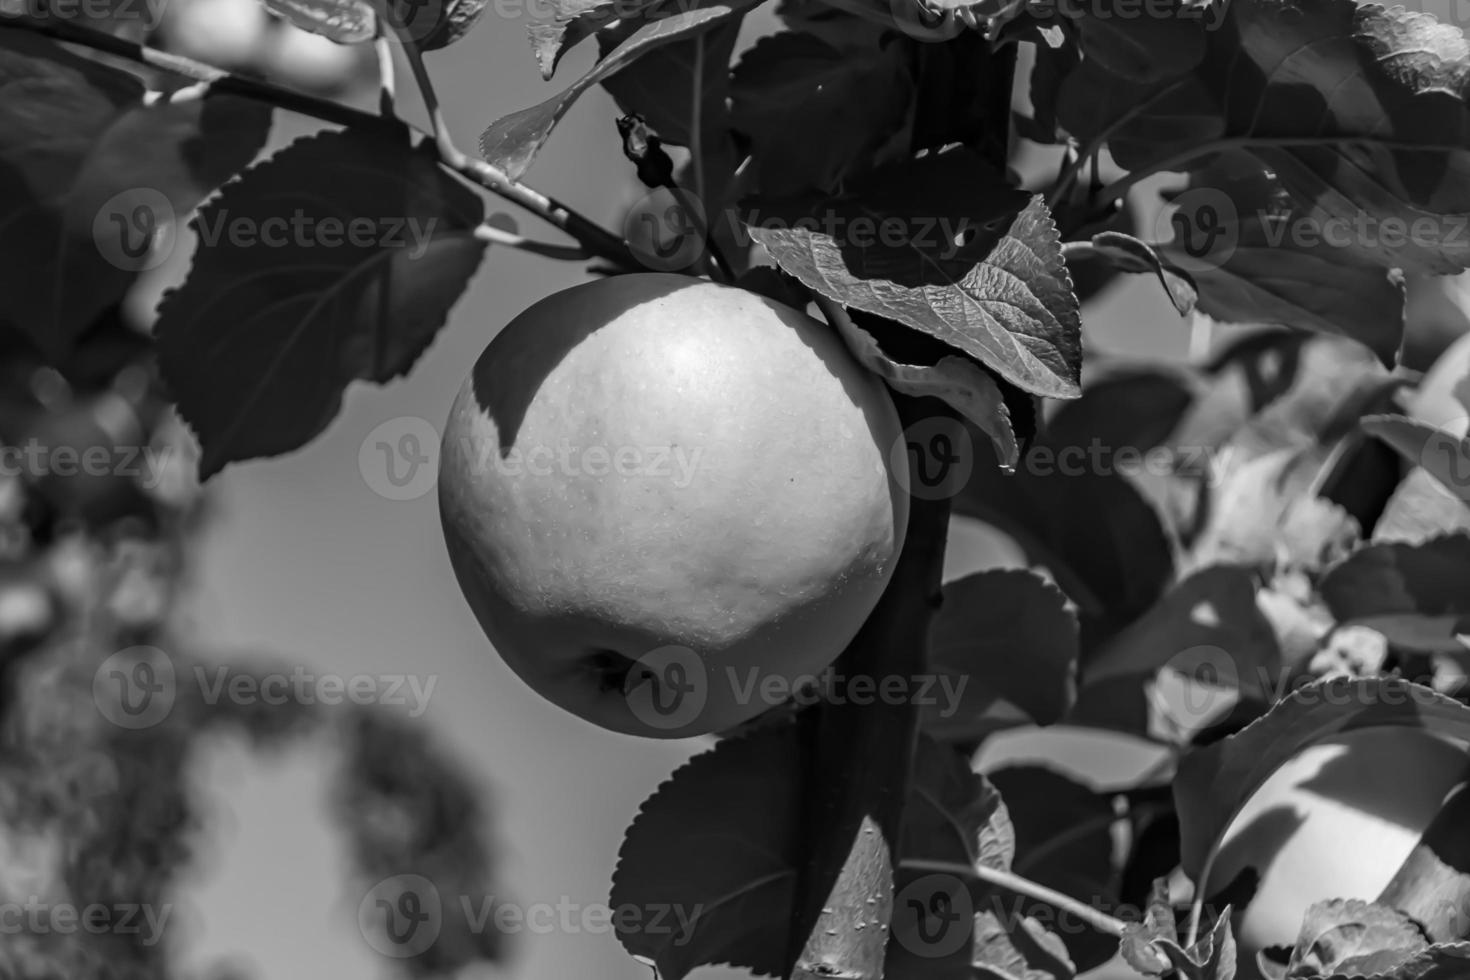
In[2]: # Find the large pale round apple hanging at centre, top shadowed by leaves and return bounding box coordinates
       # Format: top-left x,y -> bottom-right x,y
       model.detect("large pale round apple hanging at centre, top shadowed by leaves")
438,273 -> 908,738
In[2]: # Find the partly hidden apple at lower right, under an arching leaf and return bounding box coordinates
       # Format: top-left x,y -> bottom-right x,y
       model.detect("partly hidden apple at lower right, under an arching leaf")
1204,727 -> 1470,980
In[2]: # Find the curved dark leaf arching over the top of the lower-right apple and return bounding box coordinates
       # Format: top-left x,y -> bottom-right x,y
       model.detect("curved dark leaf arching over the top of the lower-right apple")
1175,676 -> 1470,882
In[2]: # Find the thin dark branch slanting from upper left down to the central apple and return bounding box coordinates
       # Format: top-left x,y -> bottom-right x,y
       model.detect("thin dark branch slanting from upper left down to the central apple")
0,15 -> 639,269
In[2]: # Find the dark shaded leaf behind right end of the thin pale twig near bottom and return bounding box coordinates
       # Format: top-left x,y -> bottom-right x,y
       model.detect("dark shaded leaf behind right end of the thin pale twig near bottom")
989,765 -> 1117,971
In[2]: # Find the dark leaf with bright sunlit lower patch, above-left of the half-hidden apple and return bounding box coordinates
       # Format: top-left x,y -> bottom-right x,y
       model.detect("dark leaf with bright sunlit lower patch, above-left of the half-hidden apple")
1073,566 -> 1282,745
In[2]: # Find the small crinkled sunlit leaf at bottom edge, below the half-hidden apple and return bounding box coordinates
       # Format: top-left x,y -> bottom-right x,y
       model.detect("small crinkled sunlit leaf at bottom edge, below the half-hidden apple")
1286,898 -> 1429,980
